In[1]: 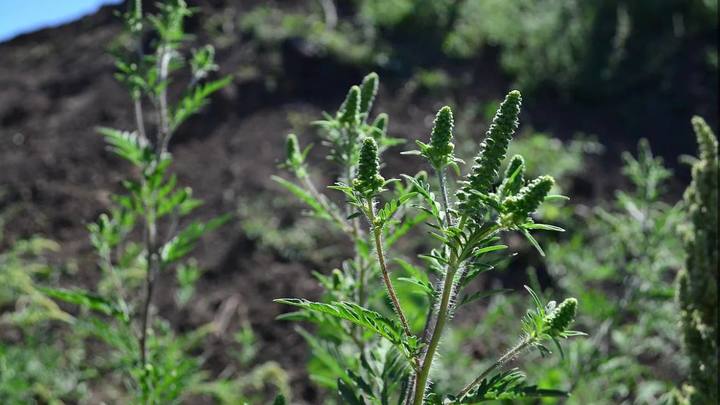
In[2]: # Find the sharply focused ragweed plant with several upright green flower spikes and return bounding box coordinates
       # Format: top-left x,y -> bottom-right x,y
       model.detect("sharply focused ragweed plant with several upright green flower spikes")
275,74 -> 580,405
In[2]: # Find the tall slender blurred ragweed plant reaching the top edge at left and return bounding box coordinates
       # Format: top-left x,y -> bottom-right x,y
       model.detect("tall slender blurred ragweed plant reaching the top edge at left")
37,0 -> 256,404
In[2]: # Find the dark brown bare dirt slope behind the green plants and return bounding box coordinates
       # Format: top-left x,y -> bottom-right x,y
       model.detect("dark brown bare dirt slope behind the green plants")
0,1 -> 717,403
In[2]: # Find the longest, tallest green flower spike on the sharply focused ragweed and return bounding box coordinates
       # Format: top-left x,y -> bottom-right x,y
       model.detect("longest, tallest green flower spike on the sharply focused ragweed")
457,90 -> 522,213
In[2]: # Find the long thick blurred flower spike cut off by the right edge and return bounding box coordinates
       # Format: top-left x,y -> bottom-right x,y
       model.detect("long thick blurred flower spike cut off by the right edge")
677,117 -> 720,404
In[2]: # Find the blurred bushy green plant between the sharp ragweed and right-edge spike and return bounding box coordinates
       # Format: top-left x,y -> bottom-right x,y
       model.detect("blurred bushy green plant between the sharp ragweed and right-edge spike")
480,140 -> 686,405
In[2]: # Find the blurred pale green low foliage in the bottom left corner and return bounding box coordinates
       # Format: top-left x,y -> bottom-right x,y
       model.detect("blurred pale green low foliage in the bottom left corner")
0,218 -> 87,405
